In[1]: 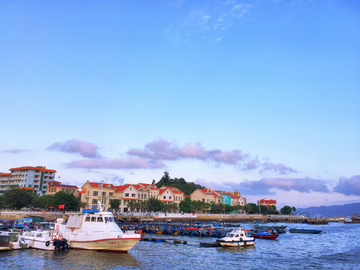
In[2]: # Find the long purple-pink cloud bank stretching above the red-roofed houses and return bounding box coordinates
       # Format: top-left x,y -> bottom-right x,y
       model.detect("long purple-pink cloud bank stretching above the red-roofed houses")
47,138 -> 297,175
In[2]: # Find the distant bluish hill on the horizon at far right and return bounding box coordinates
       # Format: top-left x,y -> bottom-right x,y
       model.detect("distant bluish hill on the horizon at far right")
296,203 -> 360,217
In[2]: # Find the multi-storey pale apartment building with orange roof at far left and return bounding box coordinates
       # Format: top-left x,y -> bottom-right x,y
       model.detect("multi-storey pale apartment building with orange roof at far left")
0,166 -> 56,196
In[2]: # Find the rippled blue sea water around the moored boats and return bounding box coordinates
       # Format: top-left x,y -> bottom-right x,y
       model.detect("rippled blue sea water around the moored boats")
0,223 -> 360,269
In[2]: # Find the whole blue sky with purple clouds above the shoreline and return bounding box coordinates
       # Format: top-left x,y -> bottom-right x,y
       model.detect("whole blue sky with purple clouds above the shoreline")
0,0 -> 360,207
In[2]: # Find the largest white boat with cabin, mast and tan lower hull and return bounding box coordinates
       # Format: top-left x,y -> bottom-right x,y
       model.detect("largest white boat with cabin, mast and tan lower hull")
55,203 -> 141,252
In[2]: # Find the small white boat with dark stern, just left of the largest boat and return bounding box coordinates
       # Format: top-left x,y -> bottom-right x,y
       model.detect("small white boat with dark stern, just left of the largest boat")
22,230 -> 69,250
